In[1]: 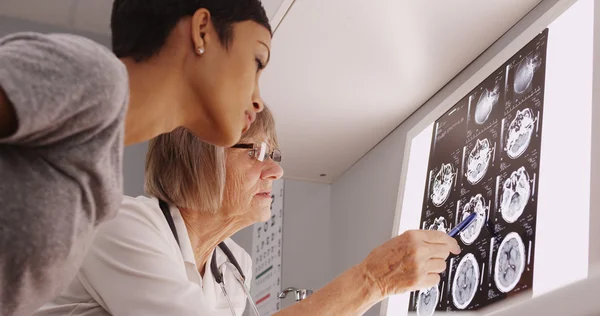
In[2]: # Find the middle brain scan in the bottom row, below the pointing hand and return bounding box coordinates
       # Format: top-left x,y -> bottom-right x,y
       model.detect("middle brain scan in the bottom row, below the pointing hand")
452,253 -> 479,309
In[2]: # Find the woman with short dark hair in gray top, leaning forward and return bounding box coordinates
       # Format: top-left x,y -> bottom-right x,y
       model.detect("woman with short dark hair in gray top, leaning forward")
0,0 -> 271,316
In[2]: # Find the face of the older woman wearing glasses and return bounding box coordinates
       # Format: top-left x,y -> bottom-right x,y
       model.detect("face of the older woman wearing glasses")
221,137 -> 283,224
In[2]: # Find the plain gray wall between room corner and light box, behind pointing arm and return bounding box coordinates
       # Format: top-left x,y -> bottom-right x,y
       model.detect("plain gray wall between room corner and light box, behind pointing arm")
330,127 -> 406,315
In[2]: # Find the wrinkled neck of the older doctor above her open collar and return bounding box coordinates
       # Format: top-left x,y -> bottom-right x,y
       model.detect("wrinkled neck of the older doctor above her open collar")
179,208 -> 248,275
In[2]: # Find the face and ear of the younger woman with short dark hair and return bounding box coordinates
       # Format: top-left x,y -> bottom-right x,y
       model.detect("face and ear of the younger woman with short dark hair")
184,10 -> 271,147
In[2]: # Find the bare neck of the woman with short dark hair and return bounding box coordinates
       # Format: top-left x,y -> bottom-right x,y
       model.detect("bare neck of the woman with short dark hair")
121,58 -> 189,145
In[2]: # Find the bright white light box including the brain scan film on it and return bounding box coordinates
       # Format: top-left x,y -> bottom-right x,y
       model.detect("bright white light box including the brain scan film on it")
382,0 -> 594,316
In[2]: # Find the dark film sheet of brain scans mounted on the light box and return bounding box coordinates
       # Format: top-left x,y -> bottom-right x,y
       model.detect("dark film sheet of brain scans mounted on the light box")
409,29 -> 548,316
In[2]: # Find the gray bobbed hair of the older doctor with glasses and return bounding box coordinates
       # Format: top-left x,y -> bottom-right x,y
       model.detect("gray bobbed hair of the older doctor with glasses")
144,106 -> 278,213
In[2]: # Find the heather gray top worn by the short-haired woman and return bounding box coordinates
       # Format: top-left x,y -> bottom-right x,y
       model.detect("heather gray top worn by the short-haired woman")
0,33 -> 128,316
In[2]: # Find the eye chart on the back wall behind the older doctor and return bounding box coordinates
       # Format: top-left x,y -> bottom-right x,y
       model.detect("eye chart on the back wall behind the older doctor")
246,180 -> 284,316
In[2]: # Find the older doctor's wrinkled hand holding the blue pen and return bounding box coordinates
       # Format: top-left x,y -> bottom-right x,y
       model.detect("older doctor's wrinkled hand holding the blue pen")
360,230 -> 460,297
